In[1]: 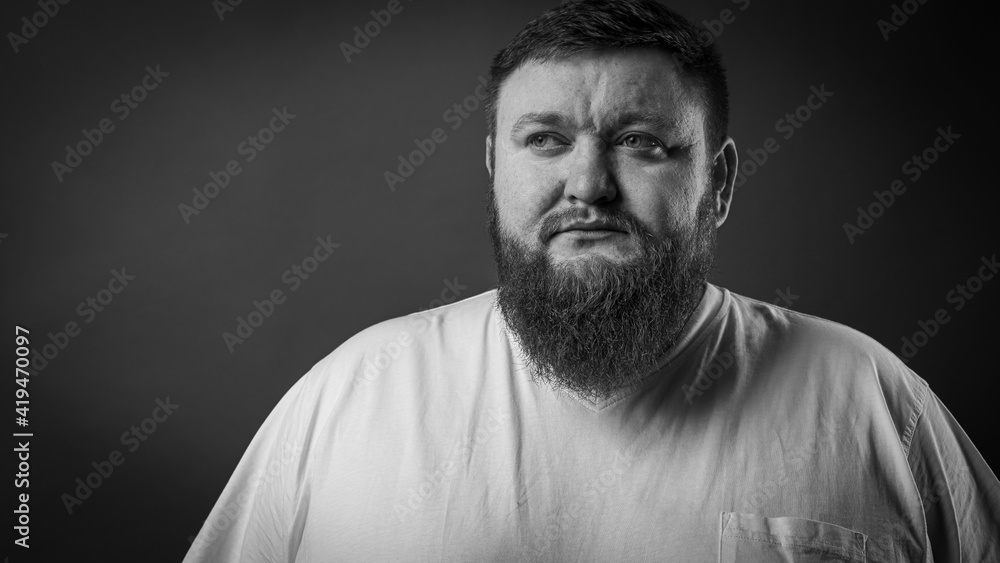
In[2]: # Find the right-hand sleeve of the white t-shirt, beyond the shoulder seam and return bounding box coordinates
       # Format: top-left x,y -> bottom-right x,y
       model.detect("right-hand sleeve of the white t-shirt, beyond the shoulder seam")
907,388 -> 1000,563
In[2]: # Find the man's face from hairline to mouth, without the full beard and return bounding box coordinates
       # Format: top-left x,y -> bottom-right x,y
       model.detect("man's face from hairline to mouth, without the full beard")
493,49 -> 721,267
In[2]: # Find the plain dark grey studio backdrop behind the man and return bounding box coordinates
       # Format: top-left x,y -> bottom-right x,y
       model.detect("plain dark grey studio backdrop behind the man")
0,0 -> 1000,561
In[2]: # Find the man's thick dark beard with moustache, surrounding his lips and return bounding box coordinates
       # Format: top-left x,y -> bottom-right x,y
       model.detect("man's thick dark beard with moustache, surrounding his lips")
488,185 -> 717,400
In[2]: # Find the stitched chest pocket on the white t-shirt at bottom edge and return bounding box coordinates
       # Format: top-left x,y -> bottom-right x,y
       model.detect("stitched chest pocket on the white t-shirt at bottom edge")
719,512 -> 868,563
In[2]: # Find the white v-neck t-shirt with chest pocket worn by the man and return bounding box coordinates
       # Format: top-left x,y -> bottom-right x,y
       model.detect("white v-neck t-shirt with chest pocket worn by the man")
185,285 -> 1000,563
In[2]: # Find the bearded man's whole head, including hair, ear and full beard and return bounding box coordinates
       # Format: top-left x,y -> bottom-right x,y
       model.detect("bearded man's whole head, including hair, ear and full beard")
487,0 -> 736,398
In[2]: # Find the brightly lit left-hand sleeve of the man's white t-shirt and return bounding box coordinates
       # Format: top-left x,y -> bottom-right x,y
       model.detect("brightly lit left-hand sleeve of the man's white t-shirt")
184,374 -> 311,563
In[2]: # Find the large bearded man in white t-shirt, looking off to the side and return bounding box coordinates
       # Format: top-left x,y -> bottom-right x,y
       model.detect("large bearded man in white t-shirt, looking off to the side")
186,0 -> 1000,562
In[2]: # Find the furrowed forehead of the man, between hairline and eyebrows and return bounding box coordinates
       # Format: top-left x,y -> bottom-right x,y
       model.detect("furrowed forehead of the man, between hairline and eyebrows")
497,48 -> 703,131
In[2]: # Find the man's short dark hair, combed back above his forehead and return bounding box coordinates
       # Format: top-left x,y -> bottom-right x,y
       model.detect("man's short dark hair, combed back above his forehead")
485,0 -> 729,158
